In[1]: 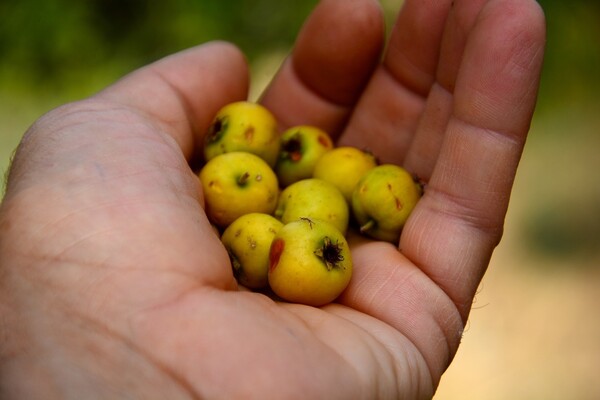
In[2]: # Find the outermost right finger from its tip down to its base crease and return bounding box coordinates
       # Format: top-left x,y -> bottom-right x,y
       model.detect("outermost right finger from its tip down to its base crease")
400,0 -> 545,320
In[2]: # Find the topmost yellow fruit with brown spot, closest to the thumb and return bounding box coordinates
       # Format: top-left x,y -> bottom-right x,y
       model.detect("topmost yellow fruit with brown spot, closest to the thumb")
204,101 -> 281,168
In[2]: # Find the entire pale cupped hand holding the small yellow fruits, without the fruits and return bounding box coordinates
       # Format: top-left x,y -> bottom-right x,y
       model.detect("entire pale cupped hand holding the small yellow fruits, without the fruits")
0,0 -> 545,399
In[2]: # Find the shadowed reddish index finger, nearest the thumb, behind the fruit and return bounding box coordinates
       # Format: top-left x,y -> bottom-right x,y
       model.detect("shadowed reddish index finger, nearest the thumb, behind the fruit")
261,0 -> 384,136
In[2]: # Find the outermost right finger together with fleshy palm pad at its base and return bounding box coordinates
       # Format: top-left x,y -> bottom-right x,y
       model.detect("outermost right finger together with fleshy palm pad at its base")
340,0 -> 544,382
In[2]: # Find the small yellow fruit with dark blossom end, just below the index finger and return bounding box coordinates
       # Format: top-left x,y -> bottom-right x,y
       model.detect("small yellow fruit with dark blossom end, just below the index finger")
275,125 -> 333,187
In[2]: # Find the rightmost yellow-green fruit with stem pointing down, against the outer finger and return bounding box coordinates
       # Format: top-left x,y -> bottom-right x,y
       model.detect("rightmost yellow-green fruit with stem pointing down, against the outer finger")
352,164 -> 421,244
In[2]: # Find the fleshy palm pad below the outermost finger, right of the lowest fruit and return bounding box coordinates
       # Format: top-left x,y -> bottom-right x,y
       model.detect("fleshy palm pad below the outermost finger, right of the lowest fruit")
338,235 -> 464,387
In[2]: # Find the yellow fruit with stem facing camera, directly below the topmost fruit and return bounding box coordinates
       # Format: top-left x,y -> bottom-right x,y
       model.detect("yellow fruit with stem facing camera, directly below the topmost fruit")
199,152 -> 279,228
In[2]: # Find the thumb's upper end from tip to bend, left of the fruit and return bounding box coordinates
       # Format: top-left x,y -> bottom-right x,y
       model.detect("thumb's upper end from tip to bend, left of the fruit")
97,42 -> 249,159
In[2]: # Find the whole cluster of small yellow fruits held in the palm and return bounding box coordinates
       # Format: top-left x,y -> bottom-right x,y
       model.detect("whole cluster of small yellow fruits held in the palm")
199,101 -> 422,306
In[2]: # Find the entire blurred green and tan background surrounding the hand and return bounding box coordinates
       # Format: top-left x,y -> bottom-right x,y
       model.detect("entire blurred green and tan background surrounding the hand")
0,0 -> 600,400
